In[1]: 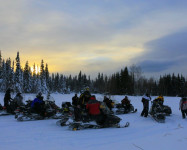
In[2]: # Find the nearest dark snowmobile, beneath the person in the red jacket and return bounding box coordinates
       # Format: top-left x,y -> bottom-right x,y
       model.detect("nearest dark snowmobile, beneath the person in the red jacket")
56,115 -> 130,131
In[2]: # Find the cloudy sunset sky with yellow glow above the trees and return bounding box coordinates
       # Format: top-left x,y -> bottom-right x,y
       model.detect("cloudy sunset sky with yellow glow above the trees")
0,0 -> 187,77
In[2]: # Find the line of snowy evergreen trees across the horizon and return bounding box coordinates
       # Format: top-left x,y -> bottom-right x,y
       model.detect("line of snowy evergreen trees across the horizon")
0,52 -> 187,96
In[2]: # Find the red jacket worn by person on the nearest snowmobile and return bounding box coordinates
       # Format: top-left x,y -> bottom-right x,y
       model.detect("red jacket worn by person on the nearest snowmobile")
86,100 -> 100,115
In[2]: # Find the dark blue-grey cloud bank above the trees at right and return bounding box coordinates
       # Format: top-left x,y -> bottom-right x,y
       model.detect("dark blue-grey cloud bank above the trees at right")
136,30 -> 187,73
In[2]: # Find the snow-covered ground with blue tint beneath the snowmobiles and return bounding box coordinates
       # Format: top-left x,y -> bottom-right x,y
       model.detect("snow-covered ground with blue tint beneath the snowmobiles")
0,93 -> 187,150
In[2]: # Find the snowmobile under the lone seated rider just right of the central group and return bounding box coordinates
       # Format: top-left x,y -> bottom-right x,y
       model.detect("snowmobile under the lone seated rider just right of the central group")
113,103 -> 137,115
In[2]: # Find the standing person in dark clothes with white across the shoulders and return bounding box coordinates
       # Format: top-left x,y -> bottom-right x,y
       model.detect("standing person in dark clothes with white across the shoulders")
141,93 -> 151,117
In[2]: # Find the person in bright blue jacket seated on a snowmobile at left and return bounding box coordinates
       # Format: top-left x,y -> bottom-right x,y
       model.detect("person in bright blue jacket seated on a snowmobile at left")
31,92 -> 45,116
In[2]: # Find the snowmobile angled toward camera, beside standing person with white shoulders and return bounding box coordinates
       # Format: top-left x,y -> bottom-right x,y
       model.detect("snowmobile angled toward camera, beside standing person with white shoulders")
149,101 -> 166,123
